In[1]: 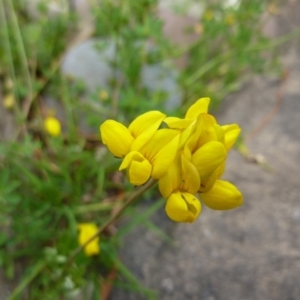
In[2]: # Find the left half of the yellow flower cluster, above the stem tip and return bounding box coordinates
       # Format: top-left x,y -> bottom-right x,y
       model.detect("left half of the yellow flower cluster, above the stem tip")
100,111 -> 179,185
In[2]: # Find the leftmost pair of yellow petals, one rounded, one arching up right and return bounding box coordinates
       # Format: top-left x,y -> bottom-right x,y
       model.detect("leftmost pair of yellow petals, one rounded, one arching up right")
100,111 -> 166,157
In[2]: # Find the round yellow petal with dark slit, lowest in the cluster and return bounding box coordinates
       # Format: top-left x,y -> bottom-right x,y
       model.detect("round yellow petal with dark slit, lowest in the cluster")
165,192 -> 201,223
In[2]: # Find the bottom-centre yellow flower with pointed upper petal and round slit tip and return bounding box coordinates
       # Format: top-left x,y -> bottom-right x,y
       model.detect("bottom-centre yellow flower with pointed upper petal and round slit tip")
159,153 -> 201,223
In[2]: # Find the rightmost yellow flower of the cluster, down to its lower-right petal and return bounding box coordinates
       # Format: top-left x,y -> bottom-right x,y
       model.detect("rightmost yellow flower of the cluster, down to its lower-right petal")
171,104 -> 243,210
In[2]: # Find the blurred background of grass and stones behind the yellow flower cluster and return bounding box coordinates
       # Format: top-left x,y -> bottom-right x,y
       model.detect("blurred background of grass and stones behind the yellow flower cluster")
0,0 -> 300,300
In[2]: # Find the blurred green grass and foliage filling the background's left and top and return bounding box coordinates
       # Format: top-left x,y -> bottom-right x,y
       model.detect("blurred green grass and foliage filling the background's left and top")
0,0 -> 290,300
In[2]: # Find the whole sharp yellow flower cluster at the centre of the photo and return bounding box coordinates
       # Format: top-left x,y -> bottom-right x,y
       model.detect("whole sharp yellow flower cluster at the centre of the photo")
100,98 -> 243,222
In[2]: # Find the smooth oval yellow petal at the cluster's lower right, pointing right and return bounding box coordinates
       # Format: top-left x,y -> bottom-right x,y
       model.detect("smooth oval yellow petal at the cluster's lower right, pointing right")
200,180 -> 243,210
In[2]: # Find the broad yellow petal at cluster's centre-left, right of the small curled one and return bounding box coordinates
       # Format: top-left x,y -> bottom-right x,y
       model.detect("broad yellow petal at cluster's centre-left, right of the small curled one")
141,129 -> 180,179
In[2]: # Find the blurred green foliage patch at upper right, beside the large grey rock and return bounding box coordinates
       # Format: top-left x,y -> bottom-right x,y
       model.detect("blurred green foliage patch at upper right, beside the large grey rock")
181,0 -> 278,110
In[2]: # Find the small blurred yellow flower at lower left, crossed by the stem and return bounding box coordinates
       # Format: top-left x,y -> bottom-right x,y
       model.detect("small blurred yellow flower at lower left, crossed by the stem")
78,223 -> 100,256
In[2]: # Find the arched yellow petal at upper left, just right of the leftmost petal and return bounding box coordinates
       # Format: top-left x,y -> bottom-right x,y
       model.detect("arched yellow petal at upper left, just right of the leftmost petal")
128,111 -> 166,151
